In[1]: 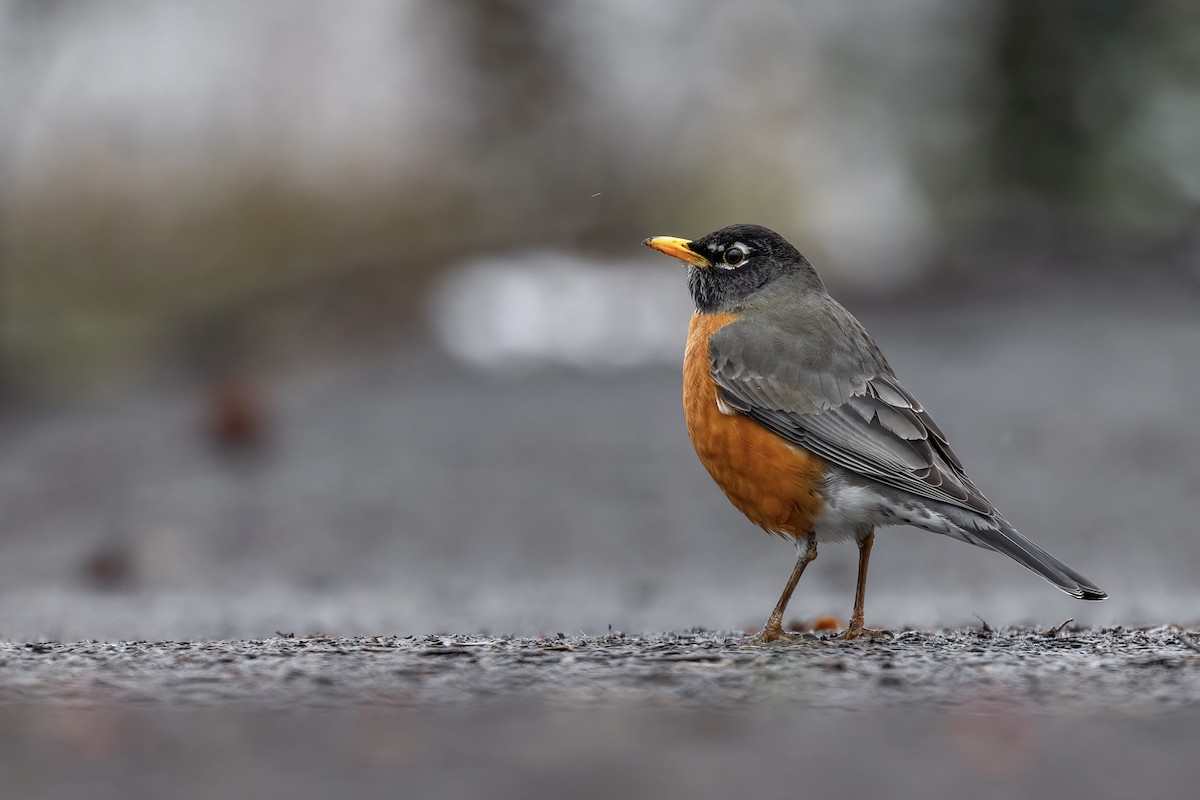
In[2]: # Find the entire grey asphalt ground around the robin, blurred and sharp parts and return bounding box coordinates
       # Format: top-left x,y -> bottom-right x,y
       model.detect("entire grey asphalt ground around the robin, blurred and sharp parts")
0,273 -> 1200,798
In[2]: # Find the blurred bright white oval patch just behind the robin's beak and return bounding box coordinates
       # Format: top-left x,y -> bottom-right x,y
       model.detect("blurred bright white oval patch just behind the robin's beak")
432,251 -> 691,369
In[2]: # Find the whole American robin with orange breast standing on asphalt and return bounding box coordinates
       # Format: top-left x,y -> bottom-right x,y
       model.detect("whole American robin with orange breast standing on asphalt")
644,225 -> 1106,642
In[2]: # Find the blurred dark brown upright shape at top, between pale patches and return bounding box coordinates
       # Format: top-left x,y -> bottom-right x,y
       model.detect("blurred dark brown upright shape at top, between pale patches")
439,0 -> 634,245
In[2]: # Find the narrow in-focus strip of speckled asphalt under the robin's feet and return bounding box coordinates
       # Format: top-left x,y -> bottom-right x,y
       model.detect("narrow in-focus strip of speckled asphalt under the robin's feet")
0,626 -> 1200,712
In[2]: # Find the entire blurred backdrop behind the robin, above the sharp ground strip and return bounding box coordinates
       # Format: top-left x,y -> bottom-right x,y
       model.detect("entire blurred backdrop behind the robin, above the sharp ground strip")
0,0 -> 1200,639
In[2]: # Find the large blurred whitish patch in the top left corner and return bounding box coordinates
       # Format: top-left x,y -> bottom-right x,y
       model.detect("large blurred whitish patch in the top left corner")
0,0 -> 449,187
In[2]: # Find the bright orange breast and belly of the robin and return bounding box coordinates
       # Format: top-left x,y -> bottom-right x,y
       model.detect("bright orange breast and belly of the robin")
683,313 -> 824,537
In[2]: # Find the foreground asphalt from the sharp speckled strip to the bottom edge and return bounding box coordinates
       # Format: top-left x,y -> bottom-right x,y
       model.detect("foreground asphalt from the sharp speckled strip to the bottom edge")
0,626 -> 1200,799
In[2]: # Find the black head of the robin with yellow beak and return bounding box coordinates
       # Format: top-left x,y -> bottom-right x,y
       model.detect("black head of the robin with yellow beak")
642,225 -> 824,312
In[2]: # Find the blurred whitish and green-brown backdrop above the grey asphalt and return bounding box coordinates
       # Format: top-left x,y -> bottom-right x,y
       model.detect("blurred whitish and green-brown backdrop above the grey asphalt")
0,0 -> 1200,391
